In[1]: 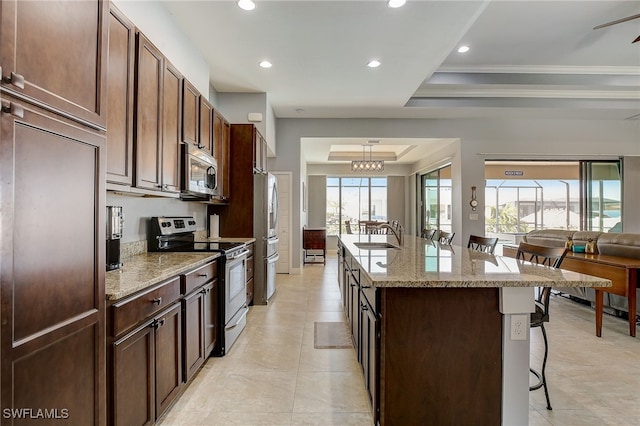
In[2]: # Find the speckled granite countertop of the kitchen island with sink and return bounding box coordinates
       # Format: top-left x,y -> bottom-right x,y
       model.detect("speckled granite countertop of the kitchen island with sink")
340,234 -> 611,288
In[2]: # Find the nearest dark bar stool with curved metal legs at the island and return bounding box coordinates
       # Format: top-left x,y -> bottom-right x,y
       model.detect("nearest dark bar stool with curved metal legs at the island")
516,242 -> 568,410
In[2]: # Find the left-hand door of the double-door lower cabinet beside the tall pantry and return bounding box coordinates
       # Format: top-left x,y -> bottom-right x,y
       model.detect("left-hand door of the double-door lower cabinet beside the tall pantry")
112,322 -> 155,425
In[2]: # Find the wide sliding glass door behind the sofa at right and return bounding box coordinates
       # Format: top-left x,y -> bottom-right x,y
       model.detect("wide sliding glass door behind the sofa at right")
485,160 -> 622,236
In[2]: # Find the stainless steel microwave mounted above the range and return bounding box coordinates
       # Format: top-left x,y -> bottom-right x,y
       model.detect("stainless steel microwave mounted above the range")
180,143 -> 218,200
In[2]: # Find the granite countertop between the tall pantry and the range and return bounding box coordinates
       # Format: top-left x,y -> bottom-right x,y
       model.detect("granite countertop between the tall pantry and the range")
105,252 -> 220,300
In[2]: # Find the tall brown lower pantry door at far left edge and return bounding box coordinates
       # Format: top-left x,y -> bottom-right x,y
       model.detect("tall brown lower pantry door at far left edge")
0,93 -> 106,424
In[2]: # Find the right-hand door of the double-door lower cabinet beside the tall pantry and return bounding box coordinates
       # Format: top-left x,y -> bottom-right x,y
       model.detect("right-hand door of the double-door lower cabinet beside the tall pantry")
154,303 -> 182,419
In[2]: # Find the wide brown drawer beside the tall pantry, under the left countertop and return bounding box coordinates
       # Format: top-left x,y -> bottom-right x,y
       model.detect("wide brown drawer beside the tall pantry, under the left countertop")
111,277 -> 180,336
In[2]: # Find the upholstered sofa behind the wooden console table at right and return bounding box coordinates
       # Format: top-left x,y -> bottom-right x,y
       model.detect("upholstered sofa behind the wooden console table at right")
523,229 -> 640,314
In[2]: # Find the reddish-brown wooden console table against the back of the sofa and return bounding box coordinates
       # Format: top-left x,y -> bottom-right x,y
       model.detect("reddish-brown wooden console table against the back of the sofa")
502,245 -> 640,337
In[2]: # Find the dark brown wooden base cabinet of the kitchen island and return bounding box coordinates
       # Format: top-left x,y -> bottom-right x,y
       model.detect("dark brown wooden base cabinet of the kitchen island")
343,252 -> 502,425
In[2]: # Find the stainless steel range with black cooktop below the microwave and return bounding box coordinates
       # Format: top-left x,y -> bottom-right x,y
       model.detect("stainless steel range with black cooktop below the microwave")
147,216 -> 249,356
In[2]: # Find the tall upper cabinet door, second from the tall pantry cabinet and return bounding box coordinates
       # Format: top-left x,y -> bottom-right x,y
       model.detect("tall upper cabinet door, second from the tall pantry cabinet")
135,33 -> 164,190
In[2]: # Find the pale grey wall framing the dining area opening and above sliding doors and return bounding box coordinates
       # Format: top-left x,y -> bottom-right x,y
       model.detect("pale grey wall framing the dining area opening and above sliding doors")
276,118 -> 640,268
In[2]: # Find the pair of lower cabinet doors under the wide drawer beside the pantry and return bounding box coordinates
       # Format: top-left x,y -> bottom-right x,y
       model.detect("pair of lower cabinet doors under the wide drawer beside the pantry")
112,303 -> 182,426
